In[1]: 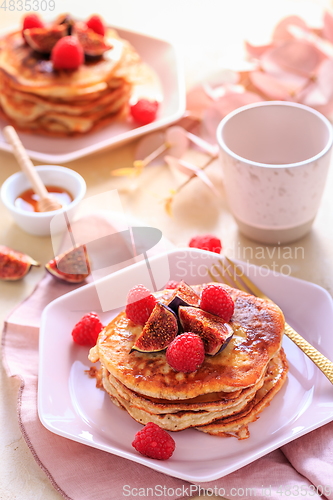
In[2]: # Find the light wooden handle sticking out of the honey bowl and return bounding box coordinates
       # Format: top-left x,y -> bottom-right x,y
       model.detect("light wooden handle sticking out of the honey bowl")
2,125 -> 49,198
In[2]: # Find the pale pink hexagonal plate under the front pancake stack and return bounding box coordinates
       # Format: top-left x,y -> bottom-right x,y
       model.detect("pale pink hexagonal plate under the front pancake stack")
38,249 -> 333,482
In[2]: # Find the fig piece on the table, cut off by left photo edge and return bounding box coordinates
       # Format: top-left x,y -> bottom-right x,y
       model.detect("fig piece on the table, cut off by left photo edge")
0,245 -> 40,281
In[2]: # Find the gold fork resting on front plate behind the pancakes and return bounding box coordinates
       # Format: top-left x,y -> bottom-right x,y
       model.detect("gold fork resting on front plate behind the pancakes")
208,257 -> 333,384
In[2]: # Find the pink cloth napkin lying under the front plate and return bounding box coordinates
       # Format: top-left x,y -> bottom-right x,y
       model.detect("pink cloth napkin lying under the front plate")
2,217 -> 333,500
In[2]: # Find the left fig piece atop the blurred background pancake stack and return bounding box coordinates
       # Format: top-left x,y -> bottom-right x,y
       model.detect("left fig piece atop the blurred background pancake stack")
23,24 -> 68,54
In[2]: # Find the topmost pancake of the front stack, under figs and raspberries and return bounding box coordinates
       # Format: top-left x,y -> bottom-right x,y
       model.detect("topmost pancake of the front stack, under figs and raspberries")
89,286 -> 284,400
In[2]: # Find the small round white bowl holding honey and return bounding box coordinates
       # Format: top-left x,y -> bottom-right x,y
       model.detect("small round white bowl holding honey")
0,165 -> 87,236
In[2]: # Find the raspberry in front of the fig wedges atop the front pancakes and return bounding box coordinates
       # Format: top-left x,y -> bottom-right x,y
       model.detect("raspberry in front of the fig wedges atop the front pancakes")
166,332 -> 205,373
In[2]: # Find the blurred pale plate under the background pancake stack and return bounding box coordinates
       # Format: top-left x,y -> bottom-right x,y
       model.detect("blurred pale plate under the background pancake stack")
0,28 -> 186,164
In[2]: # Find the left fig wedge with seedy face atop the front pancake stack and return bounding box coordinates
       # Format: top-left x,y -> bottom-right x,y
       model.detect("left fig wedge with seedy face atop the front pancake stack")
131,302 -> 178,352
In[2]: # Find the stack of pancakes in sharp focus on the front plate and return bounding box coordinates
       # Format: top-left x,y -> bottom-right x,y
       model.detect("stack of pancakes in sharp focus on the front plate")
89,285 -> 288,439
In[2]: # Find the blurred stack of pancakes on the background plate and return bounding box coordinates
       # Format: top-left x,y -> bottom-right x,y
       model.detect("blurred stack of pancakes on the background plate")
0,29 -> 152,136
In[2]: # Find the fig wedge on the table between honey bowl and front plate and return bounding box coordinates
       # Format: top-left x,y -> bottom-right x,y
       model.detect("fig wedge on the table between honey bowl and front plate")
45,245 -> 90,283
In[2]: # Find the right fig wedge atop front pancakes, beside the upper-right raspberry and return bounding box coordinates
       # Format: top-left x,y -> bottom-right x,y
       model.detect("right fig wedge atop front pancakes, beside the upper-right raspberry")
178,306 -> 234,356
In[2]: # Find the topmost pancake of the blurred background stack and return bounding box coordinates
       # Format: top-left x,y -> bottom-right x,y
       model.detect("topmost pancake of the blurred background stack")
0,28 -> 137,98
